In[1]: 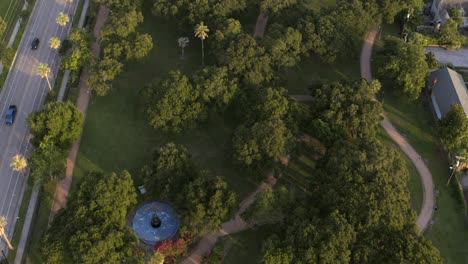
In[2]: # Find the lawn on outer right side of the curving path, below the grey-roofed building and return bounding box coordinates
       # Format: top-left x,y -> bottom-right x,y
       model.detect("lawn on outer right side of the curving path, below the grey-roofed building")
380,88 -> 468,263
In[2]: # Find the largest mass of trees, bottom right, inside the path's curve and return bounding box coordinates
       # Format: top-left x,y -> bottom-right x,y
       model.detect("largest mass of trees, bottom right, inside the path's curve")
263,140 -> 442,264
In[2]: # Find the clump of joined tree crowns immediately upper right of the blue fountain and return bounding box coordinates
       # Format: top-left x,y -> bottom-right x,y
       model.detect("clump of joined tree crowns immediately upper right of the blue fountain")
142,143 -> 236,235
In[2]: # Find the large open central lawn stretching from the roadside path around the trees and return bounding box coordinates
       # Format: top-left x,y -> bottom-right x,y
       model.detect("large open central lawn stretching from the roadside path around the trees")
72,10 -> 258,199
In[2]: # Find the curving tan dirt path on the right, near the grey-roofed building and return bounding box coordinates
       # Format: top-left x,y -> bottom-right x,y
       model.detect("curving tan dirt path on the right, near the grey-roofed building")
361,29 -> 434,234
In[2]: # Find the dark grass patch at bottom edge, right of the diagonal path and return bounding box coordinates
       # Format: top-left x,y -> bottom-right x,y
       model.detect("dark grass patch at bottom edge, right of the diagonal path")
218,226 -> 273,264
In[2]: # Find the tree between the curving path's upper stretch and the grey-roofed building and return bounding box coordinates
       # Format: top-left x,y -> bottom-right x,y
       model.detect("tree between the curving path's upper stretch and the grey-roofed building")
377,34 -> 429,100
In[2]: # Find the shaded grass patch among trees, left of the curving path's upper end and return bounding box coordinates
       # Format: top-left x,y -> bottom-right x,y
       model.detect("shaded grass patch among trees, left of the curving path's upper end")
284,56 -> 361,94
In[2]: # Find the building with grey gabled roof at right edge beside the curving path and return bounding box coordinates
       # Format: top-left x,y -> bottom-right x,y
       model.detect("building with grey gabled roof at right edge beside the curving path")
428,67 -> 468,119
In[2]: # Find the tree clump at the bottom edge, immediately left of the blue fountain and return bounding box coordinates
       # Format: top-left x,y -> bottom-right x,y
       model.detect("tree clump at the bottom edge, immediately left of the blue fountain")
42,171 -> 143,264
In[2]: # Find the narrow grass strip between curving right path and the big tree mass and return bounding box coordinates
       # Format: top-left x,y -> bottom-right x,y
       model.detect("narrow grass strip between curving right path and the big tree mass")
377,126 -> 424,215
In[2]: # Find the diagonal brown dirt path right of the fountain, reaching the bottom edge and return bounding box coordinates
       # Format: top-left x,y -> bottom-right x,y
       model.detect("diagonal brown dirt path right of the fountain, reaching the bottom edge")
182,175 -> 276,264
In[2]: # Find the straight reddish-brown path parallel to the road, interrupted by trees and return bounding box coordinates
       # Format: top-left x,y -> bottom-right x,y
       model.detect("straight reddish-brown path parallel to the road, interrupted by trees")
49,5 -> 109,223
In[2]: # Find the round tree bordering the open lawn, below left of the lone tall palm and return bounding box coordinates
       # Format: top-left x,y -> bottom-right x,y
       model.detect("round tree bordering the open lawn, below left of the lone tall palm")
143,71 -> 204,132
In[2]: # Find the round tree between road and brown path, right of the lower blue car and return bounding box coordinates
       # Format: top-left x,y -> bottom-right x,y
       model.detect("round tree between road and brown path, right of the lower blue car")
29,102 -> 83,148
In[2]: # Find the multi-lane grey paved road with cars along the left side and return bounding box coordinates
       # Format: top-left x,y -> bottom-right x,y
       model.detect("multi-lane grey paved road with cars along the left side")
0,0 -> 78,251
